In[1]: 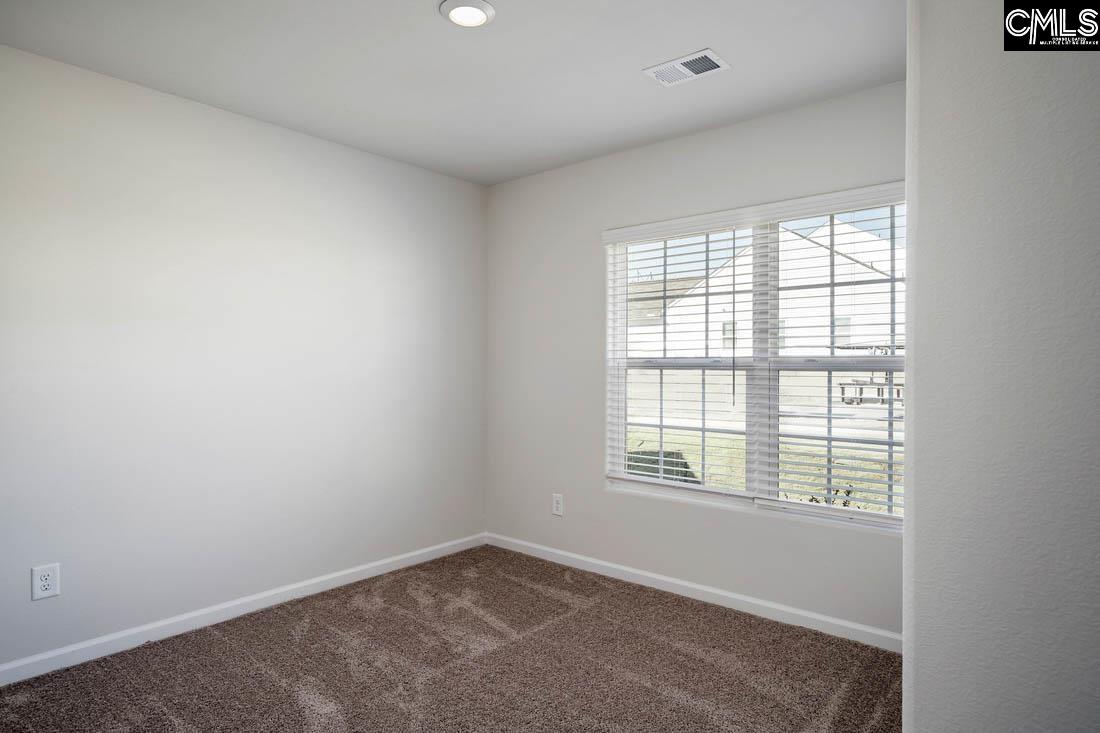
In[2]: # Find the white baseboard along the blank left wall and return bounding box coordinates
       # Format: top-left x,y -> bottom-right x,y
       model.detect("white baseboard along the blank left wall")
0,533 -> 485,686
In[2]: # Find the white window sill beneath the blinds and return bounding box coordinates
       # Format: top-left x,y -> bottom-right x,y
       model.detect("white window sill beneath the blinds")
604,475 -> 902,530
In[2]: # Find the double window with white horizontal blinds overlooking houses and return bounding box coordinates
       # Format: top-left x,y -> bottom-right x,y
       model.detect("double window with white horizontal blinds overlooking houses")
607,185 -> 905,522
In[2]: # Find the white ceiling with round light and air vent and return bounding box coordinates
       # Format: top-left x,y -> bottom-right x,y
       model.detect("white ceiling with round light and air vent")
0,0 -> 905,183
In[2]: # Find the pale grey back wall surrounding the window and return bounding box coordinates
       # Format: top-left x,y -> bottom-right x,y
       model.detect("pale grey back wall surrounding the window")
486,84 -> 905,632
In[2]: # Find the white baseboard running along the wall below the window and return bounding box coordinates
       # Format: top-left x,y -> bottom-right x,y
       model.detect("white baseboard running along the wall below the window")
485,533 -> 901,653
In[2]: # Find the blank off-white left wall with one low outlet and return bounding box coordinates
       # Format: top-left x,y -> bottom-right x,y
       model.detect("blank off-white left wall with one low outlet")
0,46 -> 485,663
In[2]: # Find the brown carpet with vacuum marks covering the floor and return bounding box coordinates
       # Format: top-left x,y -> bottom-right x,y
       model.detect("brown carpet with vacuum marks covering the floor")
0,546 -> 901,733
